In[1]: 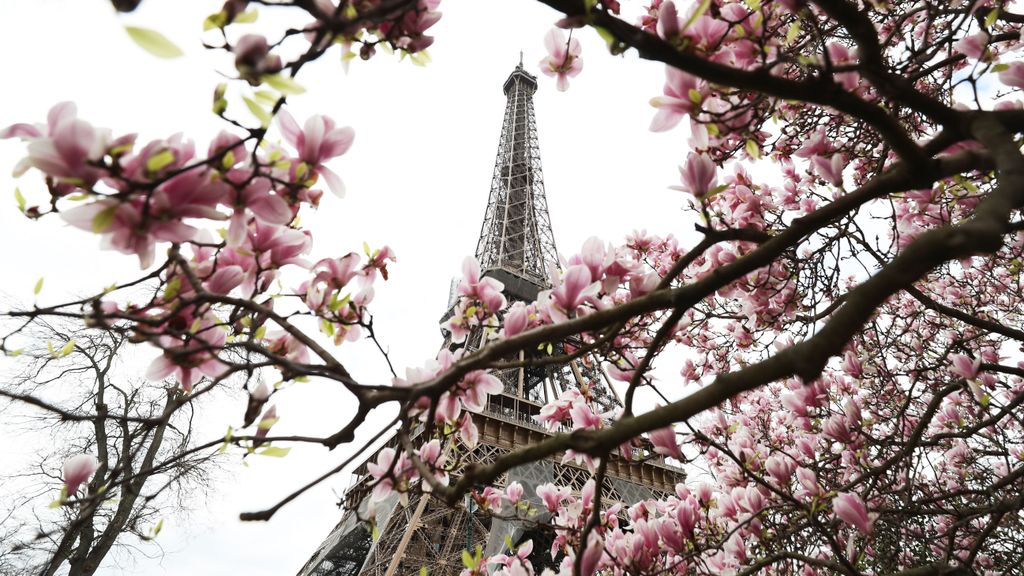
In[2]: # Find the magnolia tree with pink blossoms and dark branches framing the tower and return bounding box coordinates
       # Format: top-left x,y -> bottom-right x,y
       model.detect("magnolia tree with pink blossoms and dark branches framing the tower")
2,0 -> 1024,576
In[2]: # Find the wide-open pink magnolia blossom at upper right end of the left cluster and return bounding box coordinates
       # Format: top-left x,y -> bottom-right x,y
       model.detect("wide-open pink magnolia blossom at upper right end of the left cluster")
278,110 -> 355,197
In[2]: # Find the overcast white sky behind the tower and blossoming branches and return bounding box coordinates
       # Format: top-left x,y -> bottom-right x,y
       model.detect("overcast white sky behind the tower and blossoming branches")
0,0 -> 692,576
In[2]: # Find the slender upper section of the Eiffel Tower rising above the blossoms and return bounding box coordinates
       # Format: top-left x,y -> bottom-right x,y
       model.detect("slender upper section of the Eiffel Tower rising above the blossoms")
476,64 -> 558,300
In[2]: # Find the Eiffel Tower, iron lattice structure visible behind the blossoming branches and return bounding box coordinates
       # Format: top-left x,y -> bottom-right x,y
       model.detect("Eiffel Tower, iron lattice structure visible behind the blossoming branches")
299,58 -> 684,576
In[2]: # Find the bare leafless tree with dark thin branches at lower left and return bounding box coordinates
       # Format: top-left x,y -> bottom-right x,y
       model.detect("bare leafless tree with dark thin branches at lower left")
0,323 -> 221,575
